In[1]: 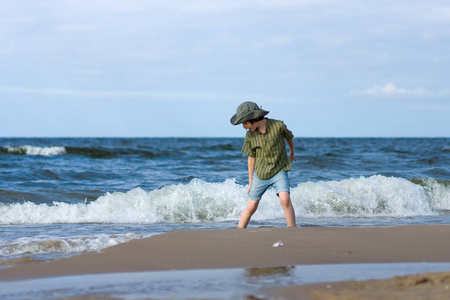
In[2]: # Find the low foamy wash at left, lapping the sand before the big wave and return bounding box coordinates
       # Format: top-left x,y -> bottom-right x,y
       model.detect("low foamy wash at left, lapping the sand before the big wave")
0,233 -> 144,256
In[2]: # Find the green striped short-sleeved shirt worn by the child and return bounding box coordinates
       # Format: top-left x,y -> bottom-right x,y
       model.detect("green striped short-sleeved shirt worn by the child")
242,119 -> 294,179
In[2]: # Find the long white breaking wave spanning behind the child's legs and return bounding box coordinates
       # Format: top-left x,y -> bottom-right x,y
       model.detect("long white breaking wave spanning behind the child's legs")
0,175 -> 450,225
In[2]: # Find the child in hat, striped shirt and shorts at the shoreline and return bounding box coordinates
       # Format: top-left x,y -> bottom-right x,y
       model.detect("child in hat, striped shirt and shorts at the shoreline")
230,102 -> 296,228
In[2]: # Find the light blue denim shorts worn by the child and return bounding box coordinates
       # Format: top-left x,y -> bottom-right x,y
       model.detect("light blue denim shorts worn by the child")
248,171 -> 290,201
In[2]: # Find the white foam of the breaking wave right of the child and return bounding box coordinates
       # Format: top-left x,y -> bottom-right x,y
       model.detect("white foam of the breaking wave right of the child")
292,175 -> 438,217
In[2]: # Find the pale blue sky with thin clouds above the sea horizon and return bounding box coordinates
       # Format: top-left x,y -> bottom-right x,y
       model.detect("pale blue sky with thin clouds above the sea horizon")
0,0 -> 450,137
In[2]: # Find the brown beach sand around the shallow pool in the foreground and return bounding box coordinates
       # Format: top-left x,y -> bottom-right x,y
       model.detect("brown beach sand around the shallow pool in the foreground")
0,225 -> 450,299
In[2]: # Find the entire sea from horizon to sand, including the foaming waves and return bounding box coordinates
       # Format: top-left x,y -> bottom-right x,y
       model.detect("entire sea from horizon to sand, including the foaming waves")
0,138 -> 450,268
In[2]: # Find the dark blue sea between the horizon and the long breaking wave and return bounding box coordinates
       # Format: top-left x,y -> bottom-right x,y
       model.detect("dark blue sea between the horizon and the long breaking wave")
0,138 -> 450,199
